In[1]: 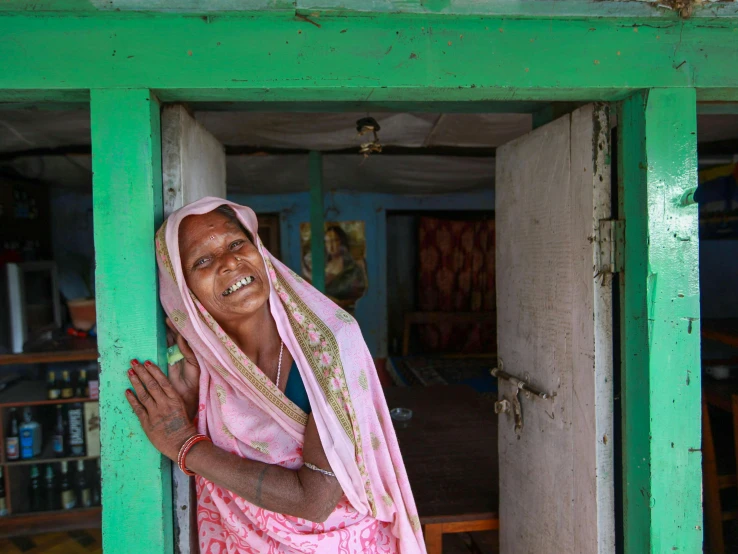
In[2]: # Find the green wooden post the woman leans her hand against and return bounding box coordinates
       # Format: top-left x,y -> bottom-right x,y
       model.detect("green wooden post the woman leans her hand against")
90,90 -> 172,554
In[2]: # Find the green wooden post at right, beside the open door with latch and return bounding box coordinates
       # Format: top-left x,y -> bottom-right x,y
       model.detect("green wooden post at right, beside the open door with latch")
619,88 -> 702,553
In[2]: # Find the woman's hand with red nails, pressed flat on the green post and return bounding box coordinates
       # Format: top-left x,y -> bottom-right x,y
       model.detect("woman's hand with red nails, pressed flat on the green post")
126,360 -> 197,461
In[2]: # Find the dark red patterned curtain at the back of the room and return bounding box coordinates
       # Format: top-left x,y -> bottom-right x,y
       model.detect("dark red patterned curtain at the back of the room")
418,217 -> 497,354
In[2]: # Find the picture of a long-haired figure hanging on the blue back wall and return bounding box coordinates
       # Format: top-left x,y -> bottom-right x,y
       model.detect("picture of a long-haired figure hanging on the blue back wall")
300,221 -> 369,314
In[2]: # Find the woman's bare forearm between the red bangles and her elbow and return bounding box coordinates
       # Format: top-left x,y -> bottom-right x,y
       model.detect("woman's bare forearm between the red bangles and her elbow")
187,436 -> 340,523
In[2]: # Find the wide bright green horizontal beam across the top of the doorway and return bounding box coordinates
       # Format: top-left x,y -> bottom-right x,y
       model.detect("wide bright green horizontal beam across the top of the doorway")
0,13 -> 738,103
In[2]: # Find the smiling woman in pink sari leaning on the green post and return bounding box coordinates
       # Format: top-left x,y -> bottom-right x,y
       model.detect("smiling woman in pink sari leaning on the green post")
126,198 -> 425,554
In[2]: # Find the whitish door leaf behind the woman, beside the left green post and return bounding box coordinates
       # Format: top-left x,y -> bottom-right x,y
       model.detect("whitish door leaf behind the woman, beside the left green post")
161,105 -> 226,554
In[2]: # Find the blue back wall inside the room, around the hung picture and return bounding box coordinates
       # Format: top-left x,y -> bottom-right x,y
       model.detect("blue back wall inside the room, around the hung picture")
228,190 -> 495,357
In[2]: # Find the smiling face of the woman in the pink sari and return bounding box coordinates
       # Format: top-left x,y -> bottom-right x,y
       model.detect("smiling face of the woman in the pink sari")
179,211 -> 269,325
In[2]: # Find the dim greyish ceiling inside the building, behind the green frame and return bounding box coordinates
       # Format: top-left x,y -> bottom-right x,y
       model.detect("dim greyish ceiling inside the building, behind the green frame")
0,109 -> 738,194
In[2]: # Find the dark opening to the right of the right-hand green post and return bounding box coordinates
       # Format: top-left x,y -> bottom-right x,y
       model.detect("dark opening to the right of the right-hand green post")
695,106 -> 738,554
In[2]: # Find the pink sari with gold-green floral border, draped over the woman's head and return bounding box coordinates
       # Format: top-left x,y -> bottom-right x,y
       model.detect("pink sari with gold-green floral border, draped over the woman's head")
156,198 -> 425,554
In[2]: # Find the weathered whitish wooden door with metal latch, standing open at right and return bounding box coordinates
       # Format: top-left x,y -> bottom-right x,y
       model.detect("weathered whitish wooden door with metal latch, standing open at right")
495,105 -> 615,554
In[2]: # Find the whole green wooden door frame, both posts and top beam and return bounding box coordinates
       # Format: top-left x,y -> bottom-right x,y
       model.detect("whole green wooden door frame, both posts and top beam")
0,8 -> 738,554
